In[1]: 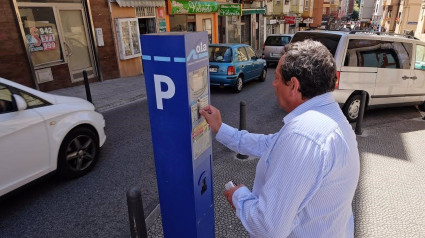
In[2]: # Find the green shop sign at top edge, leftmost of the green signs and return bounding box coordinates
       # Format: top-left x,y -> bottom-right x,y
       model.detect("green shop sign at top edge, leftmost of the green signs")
169,0 -> 218,14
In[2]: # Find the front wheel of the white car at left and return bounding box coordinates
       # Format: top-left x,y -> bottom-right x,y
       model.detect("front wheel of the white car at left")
58,127 -> 99,178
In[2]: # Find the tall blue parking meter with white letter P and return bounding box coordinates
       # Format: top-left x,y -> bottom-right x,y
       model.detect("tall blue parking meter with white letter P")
141,32 -> 214,238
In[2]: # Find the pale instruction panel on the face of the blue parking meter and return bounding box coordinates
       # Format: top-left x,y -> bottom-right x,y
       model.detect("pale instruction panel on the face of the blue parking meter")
188,67 -> 211,159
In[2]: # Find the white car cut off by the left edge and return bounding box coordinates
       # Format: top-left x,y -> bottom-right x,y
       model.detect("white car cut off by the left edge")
0,78 -> 106,196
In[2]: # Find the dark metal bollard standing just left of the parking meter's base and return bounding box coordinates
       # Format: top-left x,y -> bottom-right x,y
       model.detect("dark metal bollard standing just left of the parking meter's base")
127,187 -> 148,238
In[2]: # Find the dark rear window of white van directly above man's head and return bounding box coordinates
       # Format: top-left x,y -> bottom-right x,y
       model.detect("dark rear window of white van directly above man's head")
291,32 -> 341,57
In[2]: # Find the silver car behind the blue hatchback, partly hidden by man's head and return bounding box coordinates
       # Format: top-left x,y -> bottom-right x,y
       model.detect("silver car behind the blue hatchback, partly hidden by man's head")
263,34 -> 293,65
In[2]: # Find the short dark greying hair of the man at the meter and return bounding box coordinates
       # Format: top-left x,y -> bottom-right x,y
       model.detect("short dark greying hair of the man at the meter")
280,39 -> 336,99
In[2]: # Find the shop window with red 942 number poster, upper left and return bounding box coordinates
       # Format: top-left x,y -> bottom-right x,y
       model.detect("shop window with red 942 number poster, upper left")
19,7 -> 64,67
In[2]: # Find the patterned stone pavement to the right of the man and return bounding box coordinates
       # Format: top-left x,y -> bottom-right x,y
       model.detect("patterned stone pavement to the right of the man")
353,119 -> 425,238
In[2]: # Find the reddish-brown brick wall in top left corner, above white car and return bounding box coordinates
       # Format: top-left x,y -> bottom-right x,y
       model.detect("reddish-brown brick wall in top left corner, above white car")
0,0 -> 35,88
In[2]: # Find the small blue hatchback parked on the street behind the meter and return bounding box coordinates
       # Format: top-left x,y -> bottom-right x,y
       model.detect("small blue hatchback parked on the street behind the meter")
208,44 -> 267,92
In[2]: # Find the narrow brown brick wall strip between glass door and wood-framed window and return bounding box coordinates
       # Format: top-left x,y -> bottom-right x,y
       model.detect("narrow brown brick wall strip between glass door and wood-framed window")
90,0 -> 120,79
